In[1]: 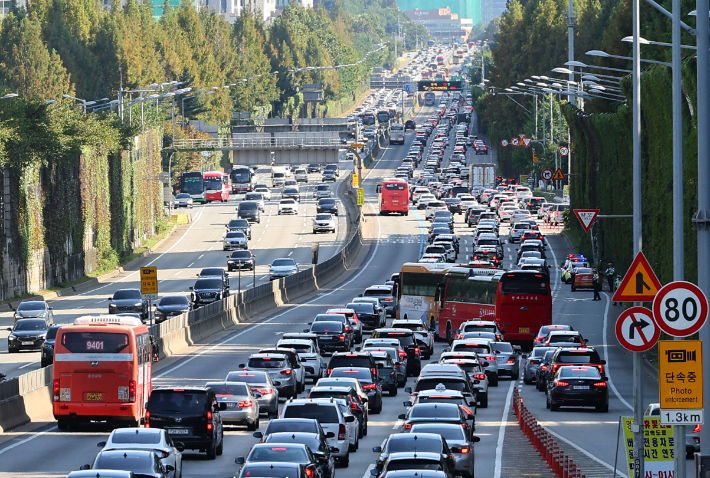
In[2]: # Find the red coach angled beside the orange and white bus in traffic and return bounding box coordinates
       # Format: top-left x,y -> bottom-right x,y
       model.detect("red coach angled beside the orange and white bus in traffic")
437,267 -> 552,347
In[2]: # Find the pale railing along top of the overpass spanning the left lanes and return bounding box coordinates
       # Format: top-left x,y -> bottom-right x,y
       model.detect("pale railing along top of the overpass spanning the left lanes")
170,136 -> 345,150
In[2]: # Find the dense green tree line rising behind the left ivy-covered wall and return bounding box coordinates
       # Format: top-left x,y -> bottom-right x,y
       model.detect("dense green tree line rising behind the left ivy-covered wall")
0,0 -> 425,123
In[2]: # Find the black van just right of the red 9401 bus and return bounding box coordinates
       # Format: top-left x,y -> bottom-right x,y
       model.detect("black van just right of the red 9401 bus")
145,387 -> 227,460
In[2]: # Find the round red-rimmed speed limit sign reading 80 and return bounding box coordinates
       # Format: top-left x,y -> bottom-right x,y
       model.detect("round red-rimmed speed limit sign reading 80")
653,281 -> 708,337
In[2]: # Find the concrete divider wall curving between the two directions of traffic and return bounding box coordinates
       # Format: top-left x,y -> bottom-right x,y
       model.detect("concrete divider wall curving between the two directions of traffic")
0,176 -> 363,433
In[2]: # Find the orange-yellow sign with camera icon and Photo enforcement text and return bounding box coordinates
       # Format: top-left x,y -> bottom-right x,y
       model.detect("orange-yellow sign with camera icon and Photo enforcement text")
658,340 -> 703,410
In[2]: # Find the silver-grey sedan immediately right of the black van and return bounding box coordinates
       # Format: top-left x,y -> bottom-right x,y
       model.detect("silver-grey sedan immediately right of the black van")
207,382 -> 261,431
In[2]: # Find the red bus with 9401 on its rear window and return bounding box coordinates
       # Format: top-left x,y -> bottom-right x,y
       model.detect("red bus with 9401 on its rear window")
52,315 -> 155,430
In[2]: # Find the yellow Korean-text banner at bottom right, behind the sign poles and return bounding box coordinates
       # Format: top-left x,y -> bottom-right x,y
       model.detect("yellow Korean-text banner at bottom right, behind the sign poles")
623,416 -> 675,476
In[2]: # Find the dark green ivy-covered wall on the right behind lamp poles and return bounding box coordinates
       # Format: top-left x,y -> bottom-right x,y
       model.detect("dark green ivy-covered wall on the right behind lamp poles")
562,58 -> 698,283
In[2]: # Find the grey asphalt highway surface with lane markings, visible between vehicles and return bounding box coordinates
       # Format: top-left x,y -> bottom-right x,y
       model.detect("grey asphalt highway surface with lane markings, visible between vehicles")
0,98 -> 680,478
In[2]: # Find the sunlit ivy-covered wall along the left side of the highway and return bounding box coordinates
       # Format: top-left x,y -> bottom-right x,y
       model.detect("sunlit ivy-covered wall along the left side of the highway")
0,100 -> 163,299
